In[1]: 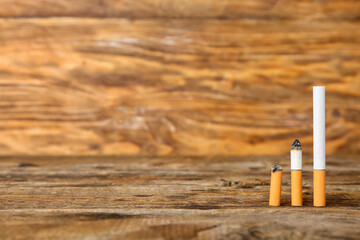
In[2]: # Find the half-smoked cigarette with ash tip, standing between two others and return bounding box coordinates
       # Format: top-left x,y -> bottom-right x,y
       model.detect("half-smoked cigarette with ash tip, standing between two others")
290,139 -> 302,206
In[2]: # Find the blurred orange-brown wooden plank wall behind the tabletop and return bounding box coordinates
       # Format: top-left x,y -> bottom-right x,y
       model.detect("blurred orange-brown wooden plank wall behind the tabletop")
0,0 -> 360,155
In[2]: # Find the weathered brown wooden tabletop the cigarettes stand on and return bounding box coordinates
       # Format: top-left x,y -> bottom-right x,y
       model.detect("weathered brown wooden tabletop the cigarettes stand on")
0,156 -> 360,239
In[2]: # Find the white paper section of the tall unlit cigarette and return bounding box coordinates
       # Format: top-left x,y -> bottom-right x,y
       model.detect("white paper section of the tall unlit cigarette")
313,86 -> 325,170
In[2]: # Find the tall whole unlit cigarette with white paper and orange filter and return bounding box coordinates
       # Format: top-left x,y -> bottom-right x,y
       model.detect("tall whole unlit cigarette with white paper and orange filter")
313,86 -> 326,207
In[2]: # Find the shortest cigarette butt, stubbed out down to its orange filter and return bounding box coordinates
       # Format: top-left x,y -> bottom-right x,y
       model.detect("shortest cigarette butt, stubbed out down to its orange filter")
269,165 -> 282,207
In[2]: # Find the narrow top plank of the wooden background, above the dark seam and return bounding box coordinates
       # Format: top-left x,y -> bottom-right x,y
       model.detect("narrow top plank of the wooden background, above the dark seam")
0,0 -> 360,20
